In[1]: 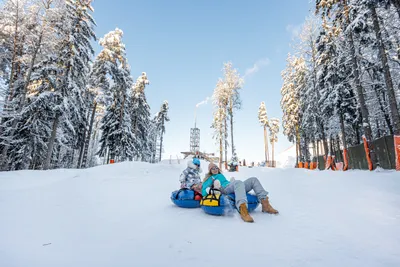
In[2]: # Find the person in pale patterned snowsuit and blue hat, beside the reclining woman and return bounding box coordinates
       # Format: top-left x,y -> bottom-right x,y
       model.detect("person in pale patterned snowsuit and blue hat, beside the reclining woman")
179,158 -> 202,194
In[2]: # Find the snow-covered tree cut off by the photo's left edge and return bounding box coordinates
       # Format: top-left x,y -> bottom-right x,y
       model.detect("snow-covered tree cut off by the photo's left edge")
0,0 -> 36,170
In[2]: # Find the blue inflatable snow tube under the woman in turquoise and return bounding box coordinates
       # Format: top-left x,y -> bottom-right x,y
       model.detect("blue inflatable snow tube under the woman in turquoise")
201,194 -> 260,216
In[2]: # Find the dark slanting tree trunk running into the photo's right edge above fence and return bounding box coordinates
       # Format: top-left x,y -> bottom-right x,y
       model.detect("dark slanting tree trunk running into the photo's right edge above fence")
370,4 -> 400,136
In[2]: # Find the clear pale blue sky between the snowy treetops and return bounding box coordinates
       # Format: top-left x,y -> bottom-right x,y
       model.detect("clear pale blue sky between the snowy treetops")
93,0 -> 312,161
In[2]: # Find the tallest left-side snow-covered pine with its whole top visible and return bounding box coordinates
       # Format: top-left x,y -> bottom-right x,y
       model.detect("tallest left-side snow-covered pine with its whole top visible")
98,28 -> 137,162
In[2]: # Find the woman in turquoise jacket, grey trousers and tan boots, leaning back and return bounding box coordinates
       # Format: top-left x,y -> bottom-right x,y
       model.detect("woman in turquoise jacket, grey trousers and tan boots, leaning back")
202,162 -> 278,222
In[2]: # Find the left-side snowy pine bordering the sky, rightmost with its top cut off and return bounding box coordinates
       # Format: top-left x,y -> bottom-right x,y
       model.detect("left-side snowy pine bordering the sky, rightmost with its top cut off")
43,0 -> 96,169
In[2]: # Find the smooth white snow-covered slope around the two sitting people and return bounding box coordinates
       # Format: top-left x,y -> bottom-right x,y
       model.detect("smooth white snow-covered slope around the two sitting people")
0,161 -> 400,267
